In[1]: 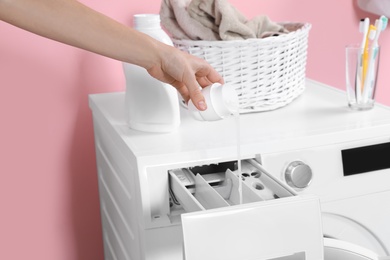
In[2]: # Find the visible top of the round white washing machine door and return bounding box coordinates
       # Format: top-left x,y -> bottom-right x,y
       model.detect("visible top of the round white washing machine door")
324,238 -> 379,260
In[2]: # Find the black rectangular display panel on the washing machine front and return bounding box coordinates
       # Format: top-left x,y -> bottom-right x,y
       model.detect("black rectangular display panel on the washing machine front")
341,142 -> 390,176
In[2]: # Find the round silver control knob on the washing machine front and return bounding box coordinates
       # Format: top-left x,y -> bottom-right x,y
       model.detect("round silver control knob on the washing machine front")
284,161 -> 313,189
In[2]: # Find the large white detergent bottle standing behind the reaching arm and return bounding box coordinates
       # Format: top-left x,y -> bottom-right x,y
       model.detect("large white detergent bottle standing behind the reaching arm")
123,14 -> 180,133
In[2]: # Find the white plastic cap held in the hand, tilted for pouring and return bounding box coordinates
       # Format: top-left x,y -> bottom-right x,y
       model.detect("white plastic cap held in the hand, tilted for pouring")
188,83 -> 239,121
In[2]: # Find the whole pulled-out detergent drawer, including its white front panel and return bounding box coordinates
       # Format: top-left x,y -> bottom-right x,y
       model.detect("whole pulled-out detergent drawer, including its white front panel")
169,160 -> 323,260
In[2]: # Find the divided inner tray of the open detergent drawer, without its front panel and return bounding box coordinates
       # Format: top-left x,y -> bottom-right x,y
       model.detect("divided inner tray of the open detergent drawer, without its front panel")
169,160 -> 296,212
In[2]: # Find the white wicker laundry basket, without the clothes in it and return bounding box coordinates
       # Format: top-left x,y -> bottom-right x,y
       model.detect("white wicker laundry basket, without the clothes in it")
173,23 -> 311,113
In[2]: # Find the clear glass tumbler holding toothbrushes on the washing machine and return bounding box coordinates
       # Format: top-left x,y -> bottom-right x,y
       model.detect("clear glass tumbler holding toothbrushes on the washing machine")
345,44 -> 380,110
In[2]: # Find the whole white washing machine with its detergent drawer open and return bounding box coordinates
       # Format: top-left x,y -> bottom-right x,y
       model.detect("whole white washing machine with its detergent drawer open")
90,80 -> 390,260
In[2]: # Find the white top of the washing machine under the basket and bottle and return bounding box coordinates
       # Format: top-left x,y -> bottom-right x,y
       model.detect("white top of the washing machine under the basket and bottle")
90,79 -> 390,166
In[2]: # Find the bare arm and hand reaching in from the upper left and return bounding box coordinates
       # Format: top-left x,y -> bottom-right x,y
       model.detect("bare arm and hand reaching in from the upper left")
0,0 -> 223,110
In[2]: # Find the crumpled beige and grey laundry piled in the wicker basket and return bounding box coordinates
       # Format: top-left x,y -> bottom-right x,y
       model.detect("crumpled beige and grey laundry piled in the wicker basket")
160,0 -> 288,41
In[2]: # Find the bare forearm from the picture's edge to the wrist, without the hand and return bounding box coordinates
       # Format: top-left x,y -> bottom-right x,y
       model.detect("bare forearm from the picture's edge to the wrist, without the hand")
0,0 -> 160,69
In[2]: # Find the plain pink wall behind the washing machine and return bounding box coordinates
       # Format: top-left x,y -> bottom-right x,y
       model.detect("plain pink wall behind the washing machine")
0,0 -> 390,260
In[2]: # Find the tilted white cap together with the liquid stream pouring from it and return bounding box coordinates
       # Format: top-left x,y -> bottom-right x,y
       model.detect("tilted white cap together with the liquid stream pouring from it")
188,83 -> 243,204
